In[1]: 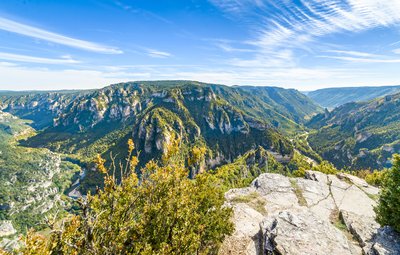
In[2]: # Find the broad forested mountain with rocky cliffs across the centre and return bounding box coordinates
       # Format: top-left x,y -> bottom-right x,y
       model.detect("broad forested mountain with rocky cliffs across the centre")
0,81 -> 321,191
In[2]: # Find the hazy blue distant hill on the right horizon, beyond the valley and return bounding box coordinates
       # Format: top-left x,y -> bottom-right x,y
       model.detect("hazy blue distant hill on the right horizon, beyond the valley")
304,86 -> 400,109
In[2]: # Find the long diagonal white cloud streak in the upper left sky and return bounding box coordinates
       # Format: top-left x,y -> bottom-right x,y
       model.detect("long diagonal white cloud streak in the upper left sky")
0,18 -> 123,54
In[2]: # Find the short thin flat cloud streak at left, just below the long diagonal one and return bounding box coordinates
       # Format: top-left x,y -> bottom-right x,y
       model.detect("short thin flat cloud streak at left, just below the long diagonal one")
0,52 -> 80,64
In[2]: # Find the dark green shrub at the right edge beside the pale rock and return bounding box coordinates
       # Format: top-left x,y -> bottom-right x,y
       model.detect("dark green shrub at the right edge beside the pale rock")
375,155 -> 400,232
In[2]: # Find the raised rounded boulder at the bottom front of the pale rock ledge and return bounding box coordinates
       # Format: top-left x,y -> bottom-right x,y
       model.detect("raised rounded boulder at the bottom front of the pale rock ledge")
260,210 -> 352,255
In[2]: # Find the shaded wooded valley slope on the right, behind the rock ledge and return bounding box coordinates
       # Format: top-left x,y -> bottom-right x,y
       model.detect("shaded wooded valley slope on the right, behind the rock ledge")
307,93 -> 400,169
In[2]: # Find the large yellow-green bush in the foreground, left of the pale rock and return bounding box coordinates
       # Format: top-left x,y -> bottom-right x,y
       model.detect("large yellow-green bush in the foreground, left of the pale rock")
18,140 -> 233,255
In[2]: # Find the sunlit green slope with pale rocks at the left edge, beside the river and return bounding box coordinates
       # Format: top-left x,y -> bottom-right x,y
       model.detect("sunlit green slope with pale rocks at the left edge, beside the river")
0,111 -> 80,238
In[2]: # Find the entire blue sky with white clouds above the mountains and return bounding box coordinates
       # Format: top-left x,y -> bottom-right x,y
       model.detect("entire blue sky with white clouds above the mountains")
0,0 -> 400,90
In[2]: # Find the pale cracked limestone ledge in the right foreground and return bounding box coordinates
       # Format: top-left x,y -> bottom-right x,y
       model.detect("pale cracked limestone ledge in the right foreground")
220,171 -> 400,255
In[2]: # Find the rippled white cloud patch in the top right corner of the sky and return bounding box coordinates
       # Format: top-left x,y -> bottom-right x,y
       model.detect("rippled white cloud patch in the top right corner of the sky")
211,0 -> 400,48
